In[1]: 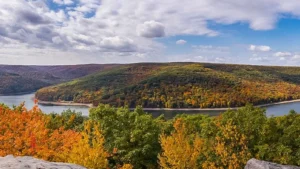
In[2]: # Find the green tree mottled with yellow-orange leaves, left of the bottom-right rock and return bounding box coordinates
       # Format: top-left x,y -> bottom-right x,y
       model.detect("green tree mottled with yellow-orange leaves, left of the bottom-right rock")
201,105 -> 267,169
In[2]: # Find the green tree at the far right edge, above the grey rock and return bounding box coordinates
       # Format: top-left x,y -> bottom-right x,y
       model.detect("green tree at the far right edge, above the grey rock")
257,111 -> 300,165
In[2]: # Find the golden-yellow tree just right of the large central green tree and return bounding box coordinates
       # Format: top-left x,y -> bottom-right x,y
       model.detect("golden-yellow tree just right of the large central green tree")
158,119 -> 203,169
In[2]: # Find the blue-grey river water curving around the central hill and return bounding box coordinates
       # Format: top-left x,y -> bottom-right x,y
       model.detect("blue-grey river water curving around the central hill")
0,94 -> 300,119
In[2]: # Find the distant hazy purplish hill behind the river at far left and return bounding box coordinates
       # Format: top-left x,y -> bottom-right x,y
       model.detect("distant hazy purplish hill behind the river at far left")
0,65 -> 117,95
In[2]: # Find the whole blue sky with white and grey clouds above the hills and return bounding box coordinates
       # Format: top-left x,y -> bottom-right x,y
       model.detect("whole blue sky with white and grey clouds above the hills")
0,0 -> 300,66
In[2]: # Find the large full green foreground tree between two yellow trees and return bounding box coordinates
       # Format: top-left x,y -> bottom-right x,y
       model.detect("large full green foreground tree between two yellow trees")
90,104 -> 160,168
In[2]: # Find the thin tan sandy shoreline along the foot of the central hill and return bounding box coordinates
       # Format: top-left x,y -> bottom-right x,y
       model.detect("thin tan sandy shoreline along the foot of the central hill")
38,99 -> 300,111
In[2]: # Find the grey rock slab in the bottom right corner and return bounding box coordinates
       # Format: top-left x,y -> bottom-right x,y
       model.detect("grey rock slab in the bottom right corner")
245,158 -> 300,169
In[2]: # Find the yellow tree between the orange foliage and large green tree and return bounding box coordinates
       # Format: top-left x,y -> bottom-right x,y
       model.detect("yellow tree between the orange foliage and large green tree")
68,121 -> 108,169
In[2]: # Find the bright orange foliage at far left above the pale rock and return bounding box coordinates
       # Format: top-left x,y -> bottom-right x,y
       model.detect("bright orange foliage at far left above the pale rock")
0,106 -> 80,161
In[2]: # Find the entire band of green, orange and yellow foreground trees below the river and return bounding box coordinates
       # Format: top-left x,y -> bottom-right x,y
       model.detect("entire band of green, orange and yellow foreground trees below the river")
0,104 -> 300,169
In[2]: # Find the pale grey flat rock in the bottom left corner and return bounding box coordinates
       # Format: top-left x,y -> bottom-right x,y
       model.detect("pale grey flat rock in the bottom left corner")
0,155 -> 86,169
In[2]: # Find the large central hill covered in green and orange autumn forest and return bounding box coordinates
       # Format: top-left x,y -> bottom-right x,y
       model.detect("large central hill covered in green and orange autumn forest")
36,63 -> 300,108
